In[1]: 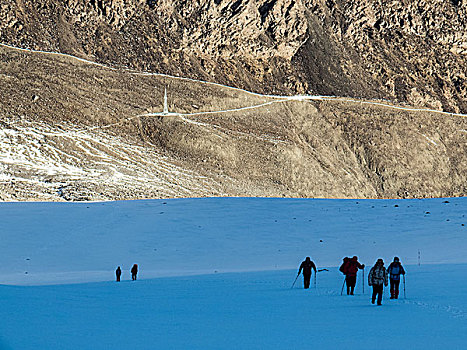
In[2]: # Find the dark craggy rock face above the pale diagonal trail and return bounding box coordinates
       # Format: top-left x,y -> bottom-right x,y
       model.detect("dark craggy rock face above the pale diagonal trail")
0,0 -> 467,112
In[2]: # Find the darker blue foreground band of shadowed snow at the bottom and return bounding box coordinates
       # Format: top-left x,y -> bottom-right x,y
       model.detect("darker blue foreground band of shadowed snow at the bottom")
0,265 -> 467,350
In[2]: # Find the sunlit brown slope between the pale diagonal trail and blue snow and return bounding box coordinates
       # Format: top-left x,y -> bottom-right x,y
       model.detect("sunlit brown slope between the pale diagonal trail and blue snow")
0,47 -> 467,200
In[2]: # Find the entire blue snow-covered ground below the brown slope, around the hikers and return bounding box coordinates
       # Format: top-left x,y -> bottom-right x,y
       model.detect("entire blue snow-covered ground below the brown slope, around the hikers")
0,198 -> 467,350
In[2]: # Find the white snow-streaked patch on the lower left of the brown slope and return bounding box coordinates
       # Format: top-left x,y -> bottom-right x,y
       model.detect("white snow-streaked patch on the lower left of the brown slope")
0,119 -> 228,197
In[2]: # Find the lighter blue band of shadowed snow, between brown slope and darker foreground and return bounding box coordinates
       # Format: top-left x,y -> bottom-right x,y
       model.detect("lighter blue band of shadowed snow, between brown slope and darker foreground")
0,198 -> 467,284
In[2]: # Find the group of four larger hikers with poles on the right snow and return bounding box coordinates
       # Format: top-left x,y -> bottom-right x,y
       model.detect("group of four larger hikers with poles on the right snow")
295,256 -> 405,305
